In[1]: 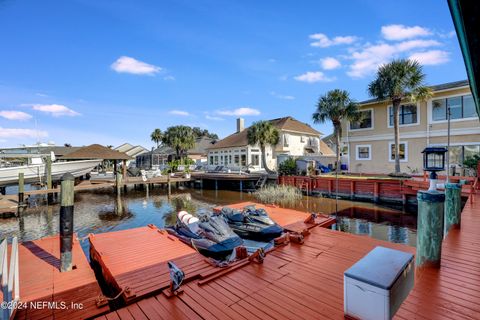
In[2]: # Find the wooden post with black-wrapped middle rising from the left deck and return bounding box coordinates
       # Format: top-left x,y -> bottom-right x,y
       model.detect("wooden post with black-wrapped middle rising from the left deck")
60,173 -> 75,272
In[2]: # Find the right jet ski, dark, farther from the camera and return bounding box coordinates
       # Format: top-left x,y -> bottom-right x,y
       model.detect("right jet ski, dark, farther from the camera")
221,206 -> 283,242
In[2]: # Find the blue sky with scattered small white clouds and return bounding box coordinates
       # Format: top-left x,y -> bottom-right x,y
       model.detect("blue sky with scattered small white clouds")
0,0 -> 466,148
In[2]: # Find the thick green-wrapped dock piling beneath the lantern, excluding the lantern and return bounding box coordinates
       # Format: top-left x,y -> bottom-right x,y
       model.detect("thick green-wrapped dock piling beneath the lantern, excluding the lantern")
416,191 -> 445,268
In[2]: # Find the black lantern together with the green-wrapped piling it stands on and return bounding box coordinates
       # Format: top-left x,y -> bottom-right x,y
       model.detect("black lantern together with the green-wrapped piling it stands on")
416,147 -> 447,267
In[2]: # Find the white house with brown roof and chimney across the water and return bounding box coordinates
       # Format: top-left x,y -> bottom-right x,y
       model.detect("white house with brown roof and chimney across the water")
208,117 -> 333,171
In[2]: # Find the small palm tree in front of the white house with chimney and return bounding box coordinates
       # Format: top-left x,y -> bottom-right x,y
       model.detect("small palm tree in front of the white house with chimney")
247,121 -> 280,173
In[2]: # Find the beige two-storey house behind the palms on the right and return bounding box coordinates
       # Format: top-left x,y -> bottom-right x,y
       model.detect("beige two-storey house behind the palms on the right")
342,81 -> 480,173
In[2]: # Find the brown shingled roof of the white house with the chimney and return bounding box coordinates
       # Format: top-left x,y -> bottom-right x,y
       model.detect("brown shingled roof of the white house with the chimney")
209,117 -> 321,149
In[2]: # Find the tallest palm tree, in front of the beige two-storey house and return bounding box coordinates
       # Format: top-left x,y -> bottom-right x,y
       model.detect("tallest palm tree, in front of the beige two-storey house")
368,59 -> 432,175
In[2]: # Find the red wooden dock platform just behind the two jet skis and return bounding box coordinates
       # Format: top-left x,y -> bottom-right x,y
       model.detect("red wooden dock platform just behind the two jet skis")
214,202 -> 335,232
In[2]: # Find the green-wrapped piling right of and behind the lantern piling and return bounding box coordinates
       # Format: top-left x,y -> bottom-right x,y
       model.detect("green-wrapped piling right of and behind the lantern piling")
443,183 -> 462,237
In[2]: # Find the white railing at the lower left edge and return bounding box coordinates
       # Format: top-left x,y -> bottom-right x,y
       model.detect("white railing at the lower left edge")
0,237 -> 20,320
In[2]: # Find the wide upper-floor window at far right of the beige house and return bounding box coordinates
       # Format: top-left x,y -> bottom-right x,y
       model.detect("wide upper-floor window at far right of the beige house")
432,94 -> 477,121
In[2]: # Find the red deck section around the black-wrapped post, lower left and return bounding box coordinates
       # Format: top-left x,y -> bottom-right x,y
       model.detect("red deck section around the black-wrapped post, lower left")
9,236 -> 109,320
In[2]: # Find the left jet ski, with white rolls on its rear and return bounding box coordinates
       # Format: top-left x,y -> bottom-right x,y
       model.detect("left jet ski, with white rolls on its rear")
166,211 -> 243,260
